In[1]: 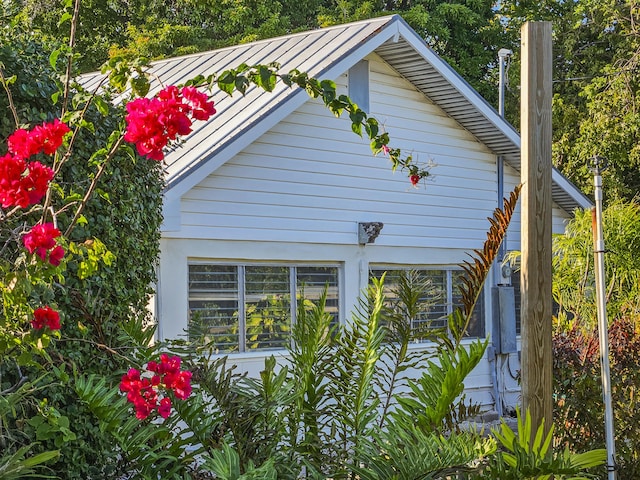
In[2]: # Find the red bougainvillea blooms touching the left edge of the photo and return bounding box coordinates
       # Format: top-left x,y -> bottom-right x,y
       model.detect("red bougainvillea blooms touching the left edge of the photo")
0,119 -> 69,208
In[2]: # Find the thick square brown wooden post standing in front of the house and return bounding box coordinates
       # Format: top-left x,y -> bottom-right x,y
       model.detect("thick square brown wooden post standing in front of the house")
520,22 -> 553,431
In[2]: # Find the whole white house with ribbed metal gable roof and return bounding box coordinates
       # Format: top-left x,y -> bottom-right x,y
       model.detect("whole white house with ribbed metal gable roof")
85,15 -> 590,412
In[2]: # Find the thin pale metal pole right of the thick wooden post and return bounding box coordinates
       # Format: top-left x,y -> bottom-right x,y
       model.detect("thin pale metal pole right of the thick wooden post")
592,156 -> 616,480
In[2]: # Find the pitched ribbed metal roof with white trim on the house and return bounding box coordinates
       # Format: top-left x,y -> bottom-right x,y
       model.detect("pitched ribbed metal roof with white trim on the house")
81,15 -> 591,212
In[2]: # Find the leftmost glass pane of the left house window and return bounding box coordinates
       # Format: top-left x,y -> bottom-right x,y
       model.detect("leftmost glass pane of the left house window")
189,265 -> 239,352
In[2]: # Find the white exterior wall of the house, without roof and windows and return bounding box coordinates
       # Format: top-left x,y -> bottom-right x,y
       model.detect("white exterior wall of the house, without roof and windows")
157,55 -> 572,406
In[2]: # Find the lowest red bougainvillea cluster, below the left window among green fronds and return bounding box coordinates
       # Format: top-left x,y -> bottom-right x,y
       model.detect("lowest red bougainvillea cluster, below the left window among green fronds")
120,353 -> 191,420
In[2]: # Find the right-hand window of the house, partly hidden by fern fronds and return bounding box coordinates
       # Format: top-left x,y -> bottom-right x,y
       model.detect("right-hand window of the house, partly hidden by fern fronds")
370,267 -> 485,338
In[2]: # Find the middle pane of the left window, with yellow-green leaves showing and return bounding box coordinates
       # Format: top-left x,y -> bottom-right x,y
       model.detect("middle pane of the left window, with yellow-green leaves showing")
245,266 -> 291,350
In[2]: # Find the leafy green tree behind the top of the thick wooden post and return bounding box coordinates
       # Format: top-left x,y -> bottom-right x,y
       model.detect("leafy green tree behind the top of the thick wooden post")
500,0 -> 640,201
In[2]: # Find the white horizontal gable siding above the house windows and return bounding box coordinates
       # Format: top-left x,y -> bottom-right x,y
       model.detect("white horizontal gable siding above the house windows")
172,56 -> 496,250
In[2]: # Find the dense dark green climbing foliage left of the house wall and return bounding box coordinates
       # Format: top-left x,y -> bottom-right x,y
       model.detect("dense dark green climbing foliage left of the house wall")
0,15 -> 163,478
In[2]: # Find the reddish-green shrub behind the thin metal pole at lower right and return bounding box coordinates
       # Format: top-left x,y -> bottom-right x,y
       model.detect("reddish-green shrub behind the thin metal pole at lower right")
553,318 -> 640,478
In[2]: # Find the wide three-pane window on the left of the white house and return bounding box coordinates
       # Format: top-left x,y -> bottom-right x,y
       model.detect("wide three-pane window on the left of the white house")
189,263 -> 339,352
